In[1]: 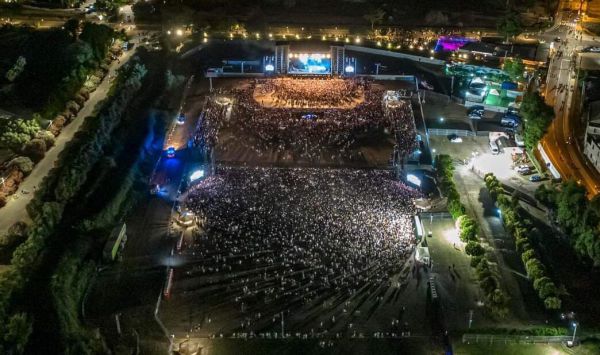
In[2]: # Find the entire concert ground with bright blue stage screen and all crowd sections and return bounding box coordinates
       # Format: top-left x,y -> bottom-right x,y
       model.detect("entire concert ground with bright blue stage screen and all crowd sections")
161,39 -> 432,338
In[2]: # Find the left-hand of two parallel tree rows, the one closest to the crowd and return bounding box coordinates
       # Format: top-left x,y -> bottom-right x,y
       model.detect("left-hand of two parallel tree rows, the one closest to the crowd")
435,154 -> 509,318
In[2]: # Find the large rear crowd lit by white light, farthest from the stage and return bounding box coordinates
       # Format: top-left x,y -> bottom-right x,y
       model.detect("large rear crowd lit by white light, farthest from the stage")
179,167 -> 418,334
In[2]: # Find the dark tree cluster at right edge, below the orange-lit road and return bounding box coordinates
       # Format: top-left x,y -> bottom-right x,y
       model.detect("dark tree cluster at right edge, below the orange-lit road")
535,181 -> 600,267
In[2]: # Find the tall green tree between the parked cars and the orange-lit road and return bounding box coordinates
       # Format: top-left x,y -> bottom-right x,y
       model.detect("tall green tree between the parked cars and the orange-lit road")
521,92 -> 554,150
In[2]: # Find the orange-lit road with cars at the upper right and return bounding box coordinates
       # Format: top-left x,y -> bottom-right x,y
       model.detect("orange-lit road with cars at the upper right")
539,0 -> 600,196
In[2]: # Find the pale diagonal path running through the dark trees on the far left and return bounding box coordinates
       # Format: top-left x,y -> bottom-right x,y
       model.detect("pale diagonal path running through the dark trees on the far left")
0,51 -> 134,234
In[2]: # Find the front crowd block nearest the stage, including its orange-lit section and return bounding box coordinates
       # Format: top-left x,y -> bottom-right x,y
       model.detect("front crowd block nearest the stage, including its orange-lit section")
198,78 -> 415,162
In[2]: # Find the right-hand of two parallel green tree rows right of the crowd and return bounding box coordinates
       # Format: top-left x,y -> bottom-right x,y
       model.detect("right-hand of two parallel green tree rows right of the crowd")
484,173 -> 562,309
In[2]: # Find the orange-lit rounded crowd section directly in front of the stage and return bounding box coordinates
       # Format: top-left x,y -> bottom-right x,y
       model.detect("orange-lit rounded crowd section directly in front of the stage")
255,77 -> 365,108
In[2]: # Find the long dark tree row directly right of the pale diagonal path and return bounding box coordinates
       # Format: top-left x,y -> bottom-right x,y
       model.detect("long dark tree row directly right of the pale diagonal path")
0,59 -> 146,353
